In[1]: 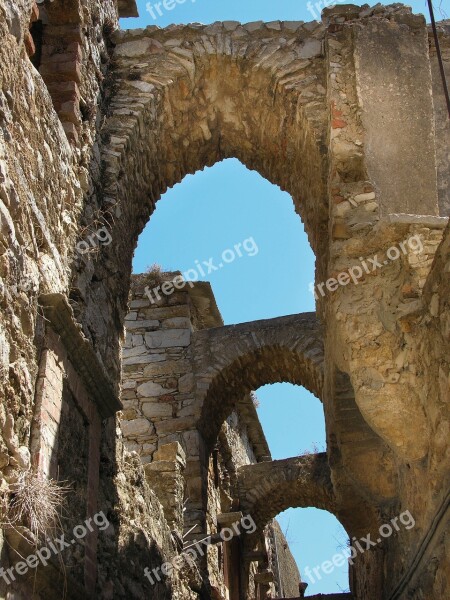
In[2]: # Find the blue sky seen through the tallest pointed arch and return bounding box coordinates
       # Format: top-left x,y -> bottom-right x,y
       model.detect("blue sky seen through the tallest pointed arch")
133,159 -> 315,324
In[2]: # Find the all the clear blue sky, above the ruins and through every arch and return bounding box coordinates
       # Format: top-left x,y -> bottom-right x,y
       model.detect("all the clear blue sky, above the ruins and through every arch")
125,0 -> 434,595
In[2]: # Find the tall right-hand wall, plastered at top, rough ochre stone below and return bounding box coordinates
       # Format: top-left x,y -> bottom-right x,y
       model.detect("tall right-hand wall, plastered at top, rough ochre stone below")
321,7 -> 448,600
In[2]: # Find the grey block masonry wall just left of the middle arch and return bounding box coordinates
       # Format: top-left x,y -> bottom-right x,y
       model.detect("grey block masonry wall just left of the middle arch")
121,274 -> 194,464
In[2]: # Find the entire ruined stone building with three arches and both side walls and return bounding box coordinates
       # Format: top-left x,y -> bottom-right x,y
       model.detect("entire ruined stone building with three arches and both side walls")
0,0 -> 450,600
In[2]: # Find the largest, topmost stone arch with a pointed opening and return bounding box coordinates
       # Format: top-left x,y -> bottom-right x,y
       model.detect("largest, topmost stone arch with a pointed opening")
73,23 -> 328,380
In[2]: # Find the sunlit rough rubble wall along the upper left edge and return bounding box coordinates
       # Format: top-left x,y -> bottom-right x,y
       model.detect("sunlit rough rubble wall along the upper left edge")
0,0 -> 125,460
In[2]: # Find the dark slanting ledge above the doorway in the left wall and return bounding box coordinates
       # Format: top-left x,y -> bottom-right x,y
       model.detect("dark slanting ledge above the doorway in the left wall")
39,294 -> 123,419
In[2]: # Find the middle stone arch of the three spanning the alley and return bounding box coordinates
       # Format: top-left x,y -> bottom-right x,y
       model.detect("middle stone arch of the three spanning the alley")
194,313 -> 323,447
